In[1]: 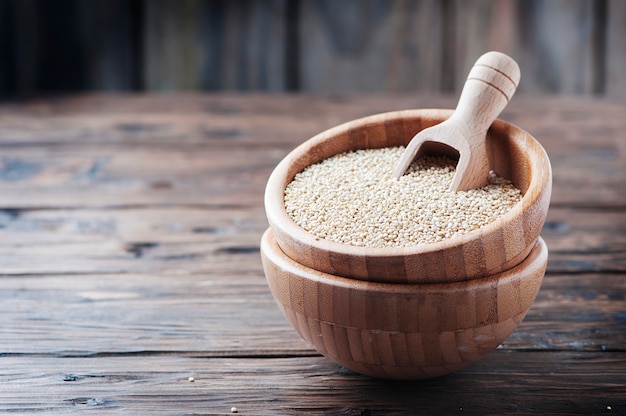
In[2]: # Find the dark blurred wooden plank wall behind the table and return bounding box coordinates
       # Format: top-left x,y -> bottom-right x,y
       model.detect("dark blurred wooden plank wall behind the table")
0,0 -> 626,101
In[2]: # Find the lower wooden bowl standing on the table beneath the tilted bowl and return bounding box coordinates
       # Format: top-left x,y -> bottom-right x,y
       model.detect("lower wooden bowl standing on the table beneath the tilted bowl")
261,230 -> 548,379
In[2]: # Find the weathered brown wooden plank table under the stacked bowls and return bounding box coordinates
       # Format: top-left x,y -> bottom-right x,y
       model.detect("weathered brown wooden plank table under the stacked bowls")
0,94 -> 626,415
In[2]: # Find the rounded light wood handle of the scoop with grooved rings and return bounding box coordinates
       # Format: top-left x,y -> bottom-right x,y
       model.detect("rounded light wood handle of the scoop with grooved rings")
450,51 -> 520,136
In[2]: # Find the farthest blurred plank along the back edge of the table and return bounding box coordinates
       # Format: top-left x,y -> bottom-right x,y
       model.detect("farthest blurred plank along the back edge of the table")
0,94 -> 626,146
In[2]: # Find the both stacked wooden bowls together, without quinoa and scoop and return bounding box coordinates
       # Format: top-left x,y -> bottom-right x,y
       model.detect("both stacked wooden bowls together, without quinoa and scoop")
261,110 -> 552,379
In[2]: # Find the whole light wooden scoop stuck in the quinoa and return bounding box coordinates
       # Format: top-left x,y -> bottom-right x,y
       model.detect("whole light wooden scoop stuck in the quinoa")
393,52 -> 520,191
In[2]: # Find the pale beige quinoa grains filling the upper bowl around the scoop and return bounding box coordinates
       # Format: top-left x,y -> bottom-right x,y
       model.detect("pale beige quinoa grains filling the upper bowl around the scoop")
284,147 -> 522,247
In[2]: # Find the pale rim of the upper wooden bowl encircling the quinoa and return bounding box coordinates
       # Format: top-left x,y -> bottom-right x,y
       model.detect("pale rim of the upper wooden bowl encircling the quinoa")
264,108 -> 552,257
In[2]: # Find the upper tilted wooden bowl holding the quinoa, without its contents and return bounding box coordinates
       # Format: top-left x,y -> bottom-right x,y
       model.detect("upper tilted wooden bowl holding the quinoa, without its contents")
265,109 -> 552,283
